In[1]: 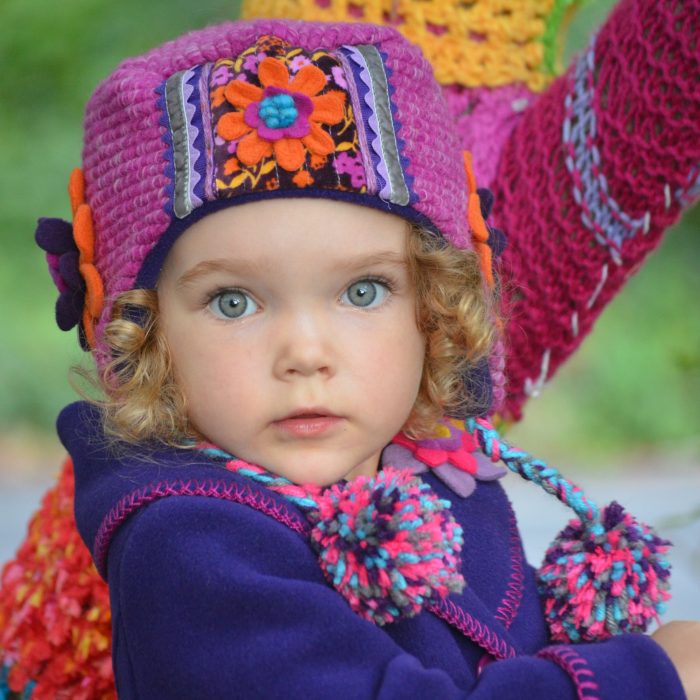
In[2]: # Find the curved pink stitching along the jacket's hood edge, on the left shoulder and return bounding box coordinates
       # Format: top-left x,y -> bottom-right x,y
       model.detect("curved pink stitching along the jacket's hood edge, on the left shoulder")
93,479 -> 309,579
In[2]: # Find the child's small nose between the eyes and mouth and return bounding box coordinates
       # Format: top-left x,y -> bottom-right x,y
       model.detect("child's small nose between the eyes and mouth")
274,310 -> 335,381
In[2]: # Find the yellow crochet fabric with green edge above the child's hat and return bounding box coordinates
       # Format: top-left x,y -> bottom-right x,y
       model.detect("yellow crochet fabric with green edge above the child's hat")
241,0 -> 578,91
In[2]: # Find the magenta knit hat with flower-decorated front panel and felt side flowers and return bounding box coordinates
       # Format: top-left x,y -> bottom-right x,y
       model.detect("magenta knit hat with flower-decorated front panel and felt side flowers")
32,20 -> 500,366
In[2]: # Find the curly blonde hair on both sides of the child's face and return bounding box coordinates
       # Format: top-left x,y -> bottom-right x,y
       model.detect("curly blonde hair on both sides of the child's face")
79,224 -> 495,446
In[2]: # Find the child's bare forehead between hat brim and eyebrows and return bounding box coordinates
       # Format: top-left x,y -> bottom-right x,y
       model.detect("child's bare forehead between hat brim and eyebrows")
165,198 -> 409,273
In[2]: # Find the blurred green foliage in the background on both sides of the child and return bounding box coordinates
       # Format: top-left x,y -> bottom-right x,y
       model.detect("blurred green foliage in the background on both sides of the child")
0,0 -> 700,464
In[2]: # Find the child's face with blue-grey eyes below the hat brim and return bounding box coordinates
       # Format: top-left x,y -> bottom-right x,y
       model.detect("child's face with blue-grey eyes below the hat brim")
158,199 -> 425,485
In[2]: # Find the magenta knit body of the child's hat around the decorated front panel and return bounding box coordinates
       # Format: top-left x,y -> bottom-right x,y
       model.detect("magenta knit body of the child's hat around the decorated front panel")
83,20 -> 470,362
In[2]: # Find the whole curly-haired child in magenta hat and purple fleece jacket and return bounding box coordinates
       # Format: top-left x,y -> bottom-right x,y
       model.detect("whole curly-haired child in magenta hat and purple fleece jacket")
1,13 -> 698,698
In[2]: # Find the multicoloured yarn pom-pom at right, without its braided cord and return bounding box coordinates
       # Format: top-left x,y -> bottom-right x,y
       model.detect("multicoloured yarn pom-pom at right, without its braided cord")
539,503 -> 670,642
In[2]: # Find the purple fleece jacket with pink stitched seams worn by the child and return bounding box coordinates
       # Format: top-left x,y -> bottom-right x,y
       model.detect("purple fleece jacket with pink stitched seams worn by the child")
58,403 -> 685,700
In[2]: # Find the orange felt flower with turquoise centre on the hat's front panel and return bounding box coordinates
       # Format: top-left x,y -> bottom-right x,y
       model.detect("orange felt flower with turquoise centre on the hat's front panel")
216,56 -> 345,171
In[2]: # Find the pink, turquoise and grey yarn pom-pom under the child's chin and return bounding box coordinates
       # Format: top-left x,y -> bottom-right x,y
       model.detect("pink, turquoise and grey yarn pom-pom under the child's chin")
311,467 -> 464,625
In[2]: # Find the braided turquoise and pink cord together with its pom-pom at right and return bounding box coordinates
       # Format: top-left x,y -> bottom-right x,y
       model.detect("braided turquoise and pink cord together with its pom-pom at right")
465,418 -> 671,642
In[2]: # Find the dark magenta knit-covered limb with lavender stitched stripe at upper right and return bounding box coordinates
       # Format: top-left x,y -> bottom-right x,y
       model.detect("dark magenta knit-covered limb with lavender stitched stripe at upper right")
494,0 -> 700,419
